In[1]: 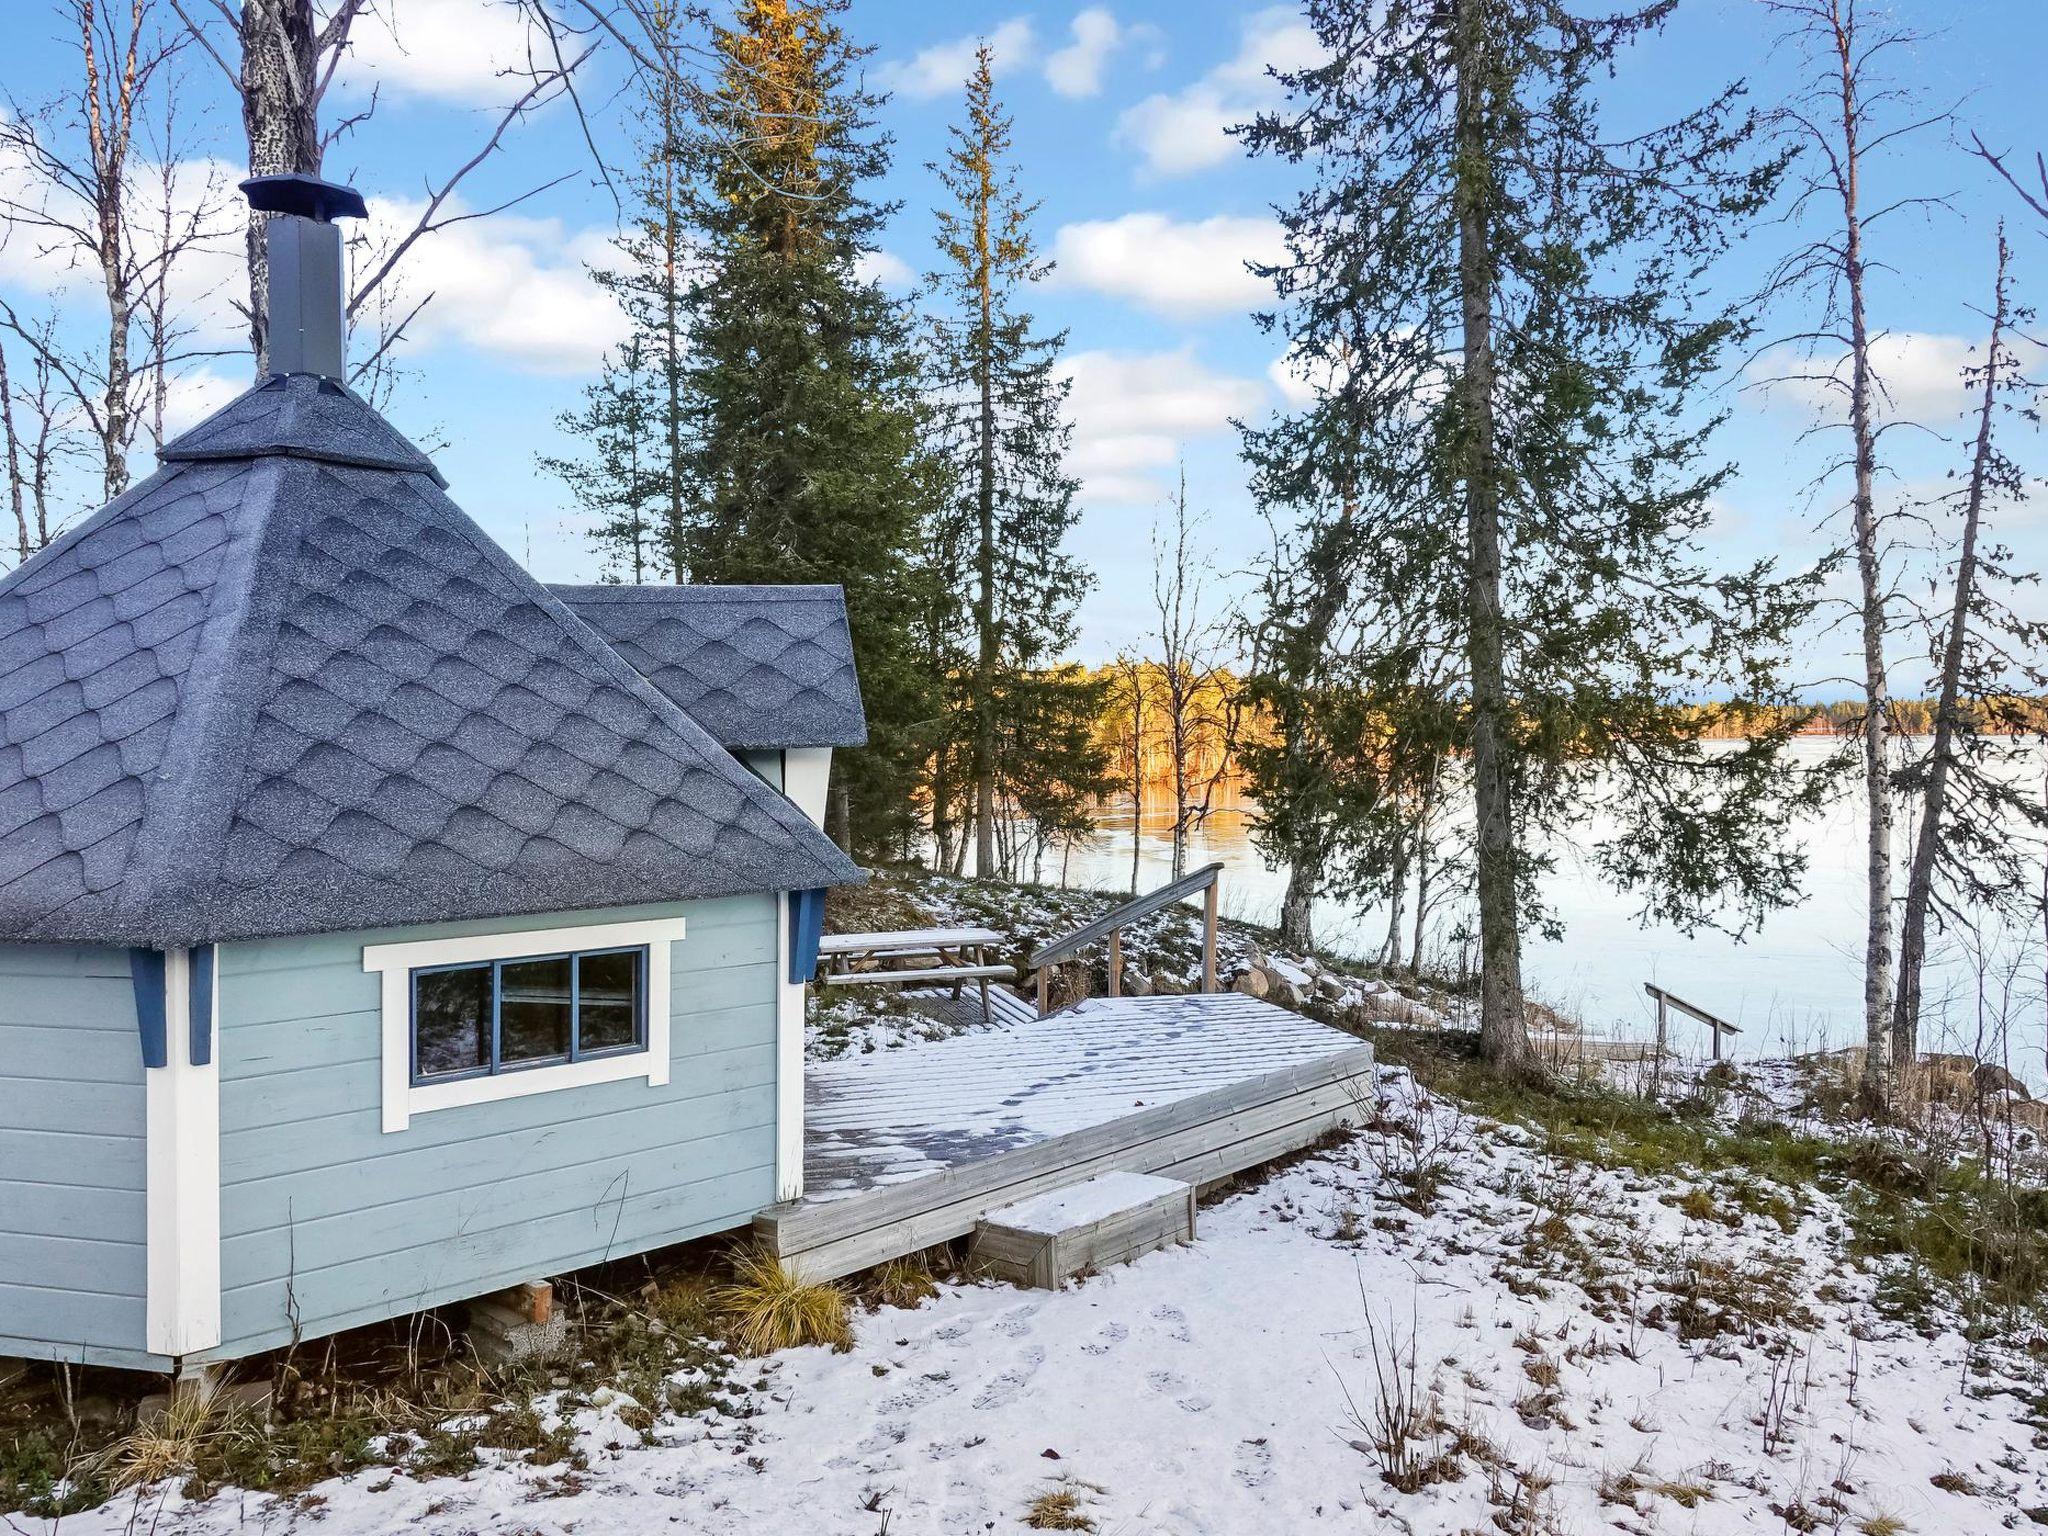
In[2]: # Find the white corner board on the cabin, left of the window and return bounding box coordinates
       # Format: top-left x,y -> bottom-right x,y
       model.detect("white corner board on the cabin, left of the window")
143,948 -> 221,1356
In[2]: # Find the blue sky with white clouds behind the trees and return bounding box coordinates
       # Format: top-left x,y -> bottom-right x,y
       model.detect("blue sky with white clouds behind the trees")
0,0 -> 2048,692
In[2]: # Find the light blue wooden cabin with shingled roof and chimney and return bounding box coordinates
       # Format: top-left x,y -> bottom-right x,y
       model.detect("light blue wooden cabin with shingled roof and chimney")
0,178 -> 864,1370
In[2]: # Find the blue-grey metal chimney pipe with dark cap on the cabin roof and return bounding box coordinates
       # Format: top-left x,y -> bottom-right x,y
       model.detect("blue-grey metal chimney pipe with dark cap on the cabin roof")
242,172 -> 369,381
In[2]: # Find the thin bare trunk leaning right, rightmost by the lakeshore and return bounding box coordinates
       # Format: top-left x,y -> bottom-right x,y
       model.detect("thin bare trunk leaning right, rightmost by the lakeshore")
1892,231 -> 2009,1061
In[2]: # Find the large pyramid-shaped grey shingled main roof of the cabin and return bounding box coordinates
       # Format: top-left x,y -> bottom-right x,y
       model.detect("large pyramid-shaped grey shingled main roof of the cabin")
0,377 -> 860,946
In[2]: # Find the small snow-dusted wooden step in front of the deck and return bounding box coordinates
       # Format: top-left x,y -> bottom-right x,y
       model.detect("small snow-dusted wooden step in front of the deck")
969,1171 -> 1194,1290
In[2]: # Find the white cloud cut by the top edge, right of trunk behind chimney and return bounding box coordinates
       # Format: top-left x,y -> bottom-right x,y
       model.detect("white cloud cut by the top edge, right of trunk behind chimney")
342,0 -> 536,104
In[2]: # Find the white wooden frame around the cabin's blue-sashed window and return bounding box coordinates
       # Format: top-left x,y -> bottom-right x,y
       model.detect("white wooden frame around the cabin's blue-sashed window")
362,918 -> 684,1133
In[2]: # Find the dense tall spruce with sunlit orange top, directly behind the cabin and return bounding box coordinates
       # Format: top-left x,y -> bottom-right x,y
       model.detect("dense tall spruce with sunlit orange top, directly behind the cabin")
676,0 -> 940,848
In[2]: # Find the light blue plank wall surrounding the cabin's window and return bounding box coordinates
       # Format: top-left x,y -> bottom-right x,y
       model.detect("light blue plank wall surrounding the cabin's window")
213,895 -> 780,1356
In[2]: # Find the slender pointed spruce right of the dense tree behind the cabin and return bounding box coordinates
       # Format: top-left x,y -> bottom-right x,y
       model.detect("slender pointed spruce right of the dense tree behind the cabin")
930,45 -> 1106,874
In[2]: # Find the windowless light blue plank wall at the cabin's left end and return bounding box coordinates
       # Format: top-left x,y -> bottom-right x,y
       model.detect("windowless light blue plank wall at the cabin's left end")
0,944 -> 150,1364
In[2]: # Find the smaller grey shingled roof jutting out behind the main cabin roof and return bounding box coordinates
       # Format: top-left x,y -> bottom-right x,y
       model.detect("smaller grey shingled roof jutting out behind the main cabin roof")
551,586 -> 868,748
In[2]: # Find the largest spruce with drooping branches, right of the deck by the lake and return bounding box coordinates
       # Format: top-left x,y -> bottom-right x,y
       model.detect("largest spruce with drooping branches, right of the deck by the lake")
1243,0 -> 1806,1073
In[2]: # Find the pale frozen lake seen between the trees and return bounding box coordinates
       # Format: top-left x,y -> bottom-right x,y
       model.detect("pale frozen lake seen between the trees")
1044,739 -> 2048,1083
